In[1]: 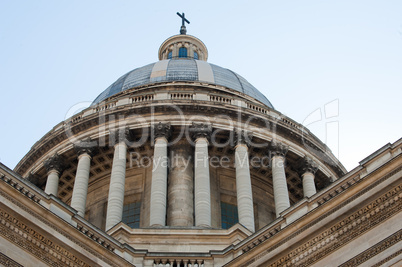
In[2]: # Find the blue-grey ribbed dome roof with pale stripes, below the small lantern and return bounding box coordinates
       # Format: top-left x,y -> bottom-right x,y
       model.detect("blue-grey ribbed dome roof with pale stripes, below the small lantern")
92,59 -> 273,108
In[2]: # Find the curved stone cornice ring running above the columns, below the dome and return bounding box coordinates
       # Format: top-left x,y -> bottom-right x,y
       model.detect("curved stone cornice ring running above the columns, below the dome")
15,96 -> 344,180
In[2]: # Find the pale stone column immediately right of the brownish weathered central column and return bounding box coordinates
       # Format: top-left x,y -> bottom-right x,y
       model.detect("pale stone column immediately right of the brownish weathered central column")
190,123 -> 212,227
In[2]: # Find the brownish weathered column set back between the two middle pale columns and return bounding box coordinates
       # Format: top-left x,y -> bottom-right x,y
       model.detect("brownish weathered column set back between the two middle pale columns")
167,139 -> 194,227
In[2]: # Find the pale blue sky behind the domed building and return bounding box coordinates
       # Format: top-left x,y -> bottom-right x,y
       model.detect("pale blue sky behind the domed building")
0,0 -> 402,170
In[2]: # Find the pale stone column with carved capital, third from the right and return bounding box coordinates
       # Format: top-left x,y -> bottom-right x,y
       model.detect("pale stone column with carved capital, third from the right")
235,130 -> 255,232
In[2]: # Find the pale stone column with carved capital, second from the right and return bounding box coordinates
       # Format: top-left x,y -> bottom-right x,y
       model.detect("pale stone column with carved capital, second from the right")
270,142 -> 290,217
